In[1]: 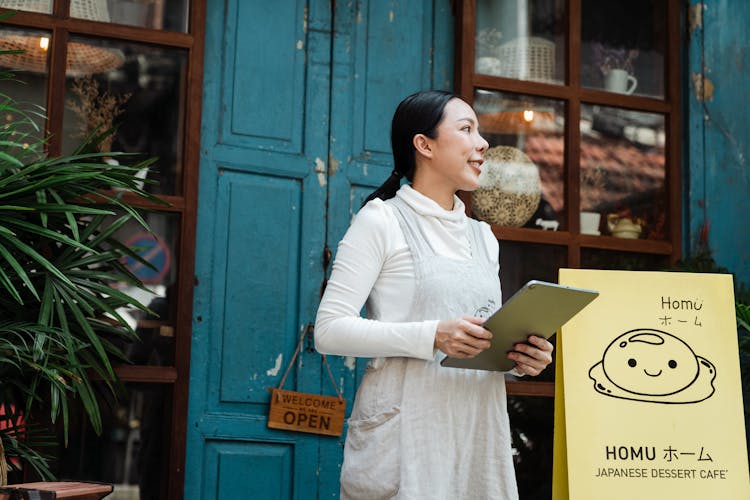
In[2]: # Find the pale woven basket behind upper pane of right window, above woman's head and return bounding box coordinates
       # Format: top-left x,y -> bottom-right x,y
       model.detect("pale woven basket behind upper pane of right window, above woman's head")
496,36 -> 555,83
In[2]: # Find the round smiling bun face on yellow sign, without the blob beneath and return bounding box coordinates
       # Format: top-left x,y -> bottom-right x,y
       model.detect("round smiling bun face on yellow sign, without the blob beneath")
602,330 -> 699,396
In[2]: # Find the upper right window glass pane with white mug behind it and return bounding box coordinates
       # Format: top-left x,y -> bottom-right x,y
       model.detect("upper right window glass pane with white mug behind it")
581,0 -> 667,98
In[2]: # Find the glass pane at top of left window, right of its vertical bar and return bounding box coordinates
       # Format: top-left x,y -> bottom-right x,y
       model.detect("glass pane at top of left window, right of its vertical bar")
70,0 -> 188,32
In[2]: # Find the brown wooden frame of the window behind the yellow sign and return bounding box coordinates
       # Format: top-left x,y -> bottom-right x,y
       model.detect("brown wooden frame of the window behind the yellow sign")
453,0 -> 683,397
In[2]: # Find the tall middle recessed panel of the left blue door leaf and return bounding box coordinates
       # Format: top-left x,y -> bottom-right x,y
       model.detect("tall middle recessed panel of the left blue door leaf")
210,172 -> 302,404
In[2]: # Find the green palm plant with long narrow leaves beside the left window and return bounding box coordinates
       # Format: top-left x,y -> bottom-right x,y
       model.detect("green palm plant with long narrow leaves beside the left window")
0,53 -> 159,479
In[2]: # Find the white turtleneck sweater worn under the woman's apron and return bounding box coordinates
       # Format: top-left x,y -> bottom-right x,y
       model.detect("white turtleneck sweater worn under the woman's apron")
315,185 -> 499,360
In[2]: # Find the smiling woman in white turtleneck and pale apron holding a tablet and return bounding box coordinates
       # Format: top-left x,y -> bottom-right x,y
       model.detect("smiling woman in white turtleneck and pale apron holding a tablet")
315,91 -> 552,500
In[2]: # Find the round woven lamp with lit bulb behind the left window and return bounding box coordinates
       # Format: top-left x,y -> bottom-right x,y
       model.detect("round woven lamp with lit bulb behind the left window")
0,0 -> 125,76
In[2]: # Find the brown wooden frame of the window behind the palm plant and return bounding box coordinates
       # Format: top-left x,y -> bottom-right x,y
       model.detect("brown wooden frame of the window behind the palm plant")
0,0 -> 206,499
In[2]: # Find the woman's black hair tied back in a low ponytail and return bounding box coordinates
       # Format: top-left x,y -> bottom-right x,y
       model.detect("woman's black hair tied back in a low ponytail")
362,90 -> 457,206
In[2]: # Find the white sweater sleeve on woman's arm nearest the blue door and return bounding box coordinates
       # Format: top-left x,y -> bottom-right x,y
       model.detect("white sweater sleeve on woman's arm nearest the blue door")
315,200 -> 438,359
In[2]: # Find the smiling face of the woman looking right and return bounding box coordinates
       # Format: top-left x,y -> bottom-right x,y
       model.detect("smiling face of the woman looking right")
429,99 -> 489,192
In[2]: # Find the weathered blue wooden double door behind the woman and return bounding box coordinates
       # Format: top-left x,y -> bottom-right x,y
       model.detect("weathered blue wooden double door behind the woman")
185,0 -> 452,500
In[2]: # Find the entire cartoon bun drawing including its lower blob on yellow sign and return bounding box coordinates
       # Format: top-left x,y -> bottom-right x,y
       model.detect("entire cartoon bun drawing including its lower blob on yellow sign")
589,328 -> 716,403
